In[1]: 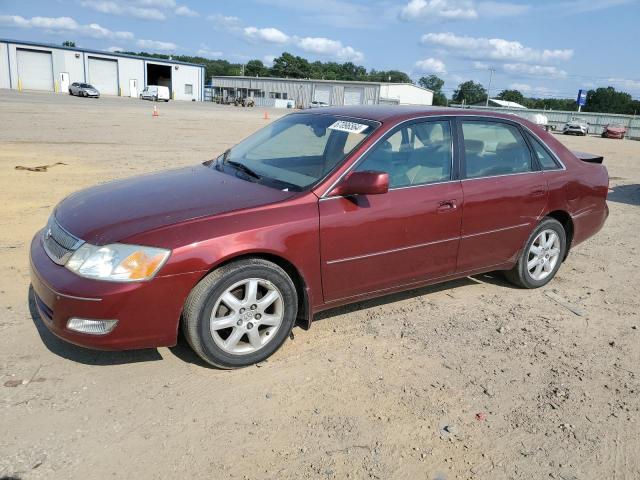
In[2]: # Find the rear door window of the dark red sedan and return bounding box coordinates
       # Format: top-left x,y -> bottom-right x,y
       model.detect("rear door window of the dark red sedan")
462,120 -> 535,178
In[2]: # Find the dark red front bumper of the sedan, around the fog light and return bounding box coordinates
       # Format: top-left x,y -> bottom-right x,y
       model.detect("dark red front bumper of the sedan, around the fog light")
30,232 -> 203,350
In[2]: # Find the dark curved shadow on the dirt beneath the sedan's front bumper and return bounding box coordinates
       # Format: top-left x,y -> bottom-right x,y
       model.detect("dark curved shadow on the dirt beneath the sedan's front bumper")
27,285 -> 162,366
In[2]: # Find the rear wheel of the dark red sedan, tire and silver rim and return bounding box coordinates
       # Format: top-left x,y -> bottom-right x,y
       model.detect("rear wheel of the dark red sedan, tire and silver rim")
505,217 -> 567,288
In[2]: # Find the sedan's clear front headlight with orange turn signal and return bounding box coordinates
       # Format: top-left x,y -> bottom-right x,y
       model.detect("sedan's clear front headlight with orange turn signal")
65,243 -> 171,282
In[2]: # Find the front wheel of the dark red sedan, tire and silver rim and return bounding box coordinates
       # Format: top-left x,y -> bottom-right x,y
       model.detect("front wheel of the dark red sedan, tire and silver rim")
182,258 -> 298,369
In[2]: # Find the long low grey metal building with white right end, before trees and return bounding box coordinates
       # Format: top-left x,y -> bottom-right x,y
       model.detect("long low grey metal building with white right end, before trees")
211,76 -> 433,108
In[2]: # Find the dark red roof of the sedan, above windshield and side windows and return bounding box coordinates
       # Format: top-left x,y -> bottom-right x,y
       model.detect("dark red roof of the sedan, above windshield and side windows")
311,105 -> 522,123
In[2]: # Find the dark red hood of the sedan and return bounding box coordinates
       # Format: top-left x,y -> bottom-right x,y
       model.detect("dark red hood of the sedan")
55,165 -> 294,245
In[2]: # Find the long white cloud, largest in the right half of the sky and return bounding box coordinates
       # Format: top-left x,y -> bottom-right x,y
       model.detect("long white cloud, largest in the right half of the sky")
422,33 -> 573,63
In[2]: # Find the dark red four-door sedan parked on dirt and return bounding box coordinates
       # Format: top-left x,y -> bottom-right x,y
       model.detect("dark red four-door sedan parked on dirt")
31,106 -> 608,368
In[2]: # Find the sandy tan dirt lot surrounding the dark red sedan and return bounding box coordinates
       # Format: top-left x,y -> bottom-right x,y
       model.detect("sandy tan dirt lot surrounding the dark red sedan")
0,91 -> 640,480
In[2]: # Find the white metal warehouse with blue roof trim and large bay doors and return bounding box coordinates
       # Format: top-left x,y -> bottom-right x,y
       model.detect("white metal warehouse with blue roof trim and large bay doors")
0,39 -> 204,101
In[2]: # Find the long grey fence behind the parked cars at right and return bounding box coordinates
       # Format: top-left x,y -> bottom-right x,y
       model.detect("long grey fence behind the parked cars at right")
452,106 -> 640,140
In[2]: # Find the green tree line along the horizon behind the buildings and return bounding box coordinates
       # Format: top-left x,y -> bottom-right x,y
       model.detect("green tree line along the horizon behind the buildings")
115,47 -> 640,115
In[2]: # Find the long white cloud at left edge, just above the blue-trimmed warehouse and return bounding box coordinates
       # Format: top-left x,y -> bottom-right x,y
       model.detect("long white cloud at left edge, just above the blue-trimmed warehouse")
0,15 -> 134,40
